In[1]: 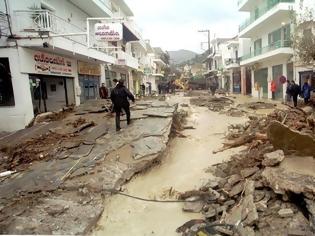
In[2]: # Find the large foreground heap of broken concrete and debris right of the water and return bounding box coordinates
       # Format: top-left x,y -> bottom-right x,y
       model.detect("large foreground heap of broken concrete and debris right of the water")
177,109 -> 315,236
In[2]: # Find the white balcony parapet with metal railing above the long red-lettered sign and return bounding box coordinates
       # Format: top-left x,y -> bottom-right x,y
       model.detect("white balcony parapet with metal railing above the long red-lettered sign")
14,10 -> 87,45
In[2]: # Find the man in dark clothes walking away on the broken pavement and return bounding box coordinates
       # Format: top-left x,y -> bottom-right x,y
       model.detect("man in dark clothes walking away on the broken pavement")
110,80 -> 135,131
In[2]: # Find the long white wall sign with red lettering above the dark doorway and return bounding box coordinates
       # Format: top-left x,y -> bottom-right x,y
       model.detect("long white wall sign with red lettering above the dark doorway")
20,49 -> 76,77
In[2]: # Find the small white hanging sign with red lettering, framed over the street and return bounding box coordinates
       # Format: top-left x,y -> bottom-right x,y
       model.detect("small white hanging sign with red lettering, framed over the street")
95,23 -> 123,42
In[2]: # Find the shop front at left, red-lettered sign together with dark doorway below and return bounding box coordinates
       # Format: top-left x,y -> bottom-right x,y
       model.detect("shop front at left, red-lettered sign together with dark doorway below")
20,49 -> 76,114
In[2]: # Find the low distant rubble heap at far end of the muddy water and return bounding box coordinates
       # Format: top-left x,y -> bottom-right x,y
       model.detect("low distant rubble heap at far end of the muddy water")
190,96 -> 234,112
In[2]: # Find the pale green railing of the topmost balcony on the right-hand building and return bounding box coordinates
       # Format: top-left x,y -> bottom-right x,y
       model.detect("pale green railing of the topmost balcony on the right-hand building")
239,0 -> 295,32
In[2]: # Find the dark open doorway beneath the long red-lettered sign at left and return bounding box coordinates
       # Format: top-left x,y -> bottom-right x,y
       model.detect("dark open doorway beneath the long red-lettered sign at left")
29,74 -> 75,114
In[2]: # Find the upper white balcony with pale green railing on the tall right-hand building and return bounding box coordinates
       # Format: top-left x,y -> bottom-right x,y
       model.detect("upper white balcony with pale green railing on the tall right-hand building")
239,0 -> 295,38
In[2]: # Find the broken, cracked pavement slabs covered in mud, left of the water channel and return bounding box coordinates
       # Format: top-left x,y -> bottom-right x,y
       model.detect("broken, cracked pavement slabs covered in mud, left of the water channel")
0,100 -> 177,234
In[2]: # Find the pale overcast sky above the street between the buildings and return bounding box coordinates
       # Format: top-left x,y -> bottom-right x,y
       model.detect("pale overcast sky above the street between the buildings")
125,0 -> 248,53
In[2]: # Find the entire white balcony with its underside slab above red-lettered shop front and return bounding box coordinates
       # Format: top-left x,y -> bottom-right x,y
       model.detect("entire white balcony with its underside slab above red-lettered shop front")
12,10 -> 116,63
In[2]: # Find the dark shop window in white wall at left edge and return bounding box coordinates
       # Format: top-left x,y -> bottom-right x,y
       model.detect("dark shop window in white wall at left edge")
0,58 -> 15,106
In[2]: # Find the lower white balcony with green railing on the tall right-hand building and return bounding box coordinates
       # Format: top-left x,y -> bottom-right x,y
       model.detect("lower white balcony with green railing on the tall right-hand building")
241,40 -> 293,66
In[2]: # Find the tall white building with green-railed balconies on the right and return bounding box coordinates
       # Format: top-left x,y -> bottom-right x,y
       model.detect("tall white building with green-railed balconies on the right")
238,0 -> 295,99
